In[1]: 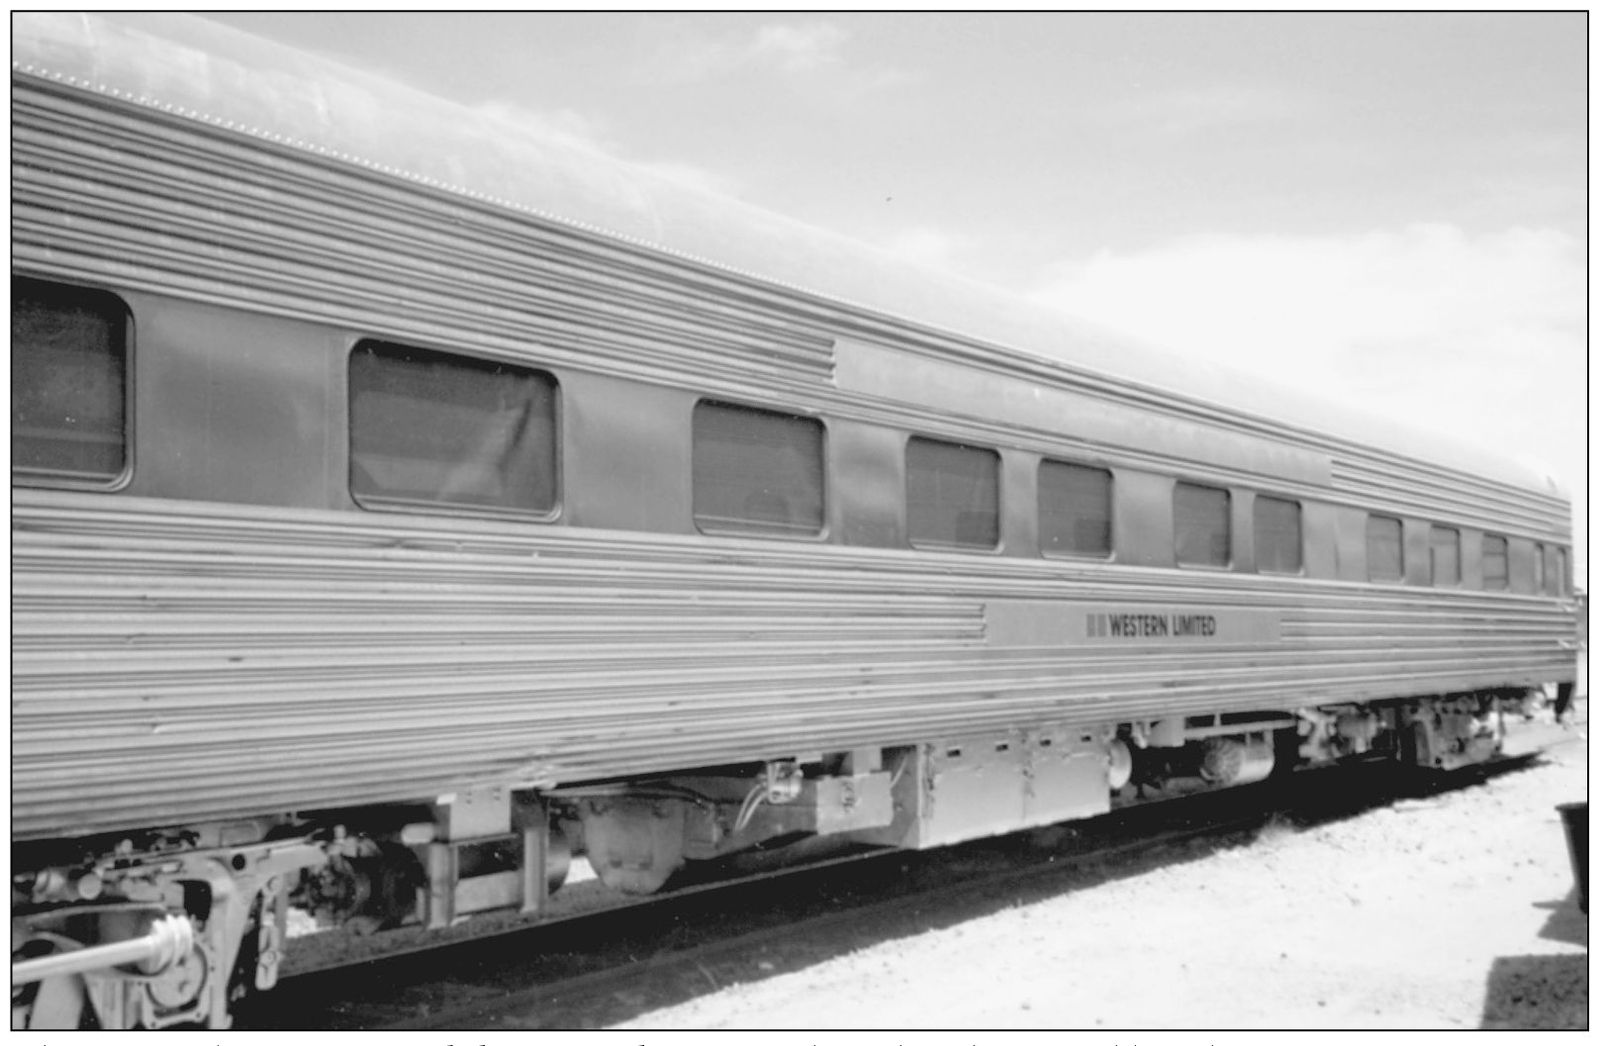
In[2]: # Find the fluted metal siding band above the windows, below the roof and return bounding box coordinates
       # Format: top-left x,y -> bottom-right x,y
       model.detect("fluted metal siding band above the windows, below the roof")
11,77 -> 1569,542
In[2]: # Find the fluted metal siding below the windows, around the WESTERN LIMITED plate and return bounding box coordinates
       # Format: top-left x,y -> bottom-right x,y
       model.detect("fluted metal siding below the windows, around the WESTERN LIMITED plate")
11,489 -> 1572,837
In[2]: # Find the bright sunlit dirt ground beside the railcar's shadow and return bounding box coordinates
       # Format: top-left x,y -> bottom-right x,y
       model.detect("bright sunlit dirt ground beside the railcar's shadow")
621,709 -> 1586,1030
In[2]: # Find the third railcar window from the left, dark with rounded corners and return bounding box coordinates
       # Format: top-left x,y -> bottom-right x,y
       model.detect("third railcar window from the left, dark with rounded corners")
691,403 -> 824,536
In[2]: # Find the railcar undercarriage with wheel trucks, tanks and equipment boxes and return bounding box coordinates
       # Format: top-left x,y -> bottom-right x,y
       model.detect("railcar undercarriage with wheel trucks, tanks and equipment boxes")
11,690 -> 1527,1028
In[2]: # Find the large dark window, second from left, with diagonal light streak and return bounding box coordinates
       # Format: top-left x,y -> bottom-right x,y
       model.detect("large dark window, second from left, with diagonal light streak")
351,342 -> 557,513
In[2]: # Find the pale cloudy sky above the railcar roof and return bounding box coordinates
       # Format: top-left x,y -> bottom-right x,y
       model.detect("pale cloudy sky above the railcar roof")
210,13 -> 1586,570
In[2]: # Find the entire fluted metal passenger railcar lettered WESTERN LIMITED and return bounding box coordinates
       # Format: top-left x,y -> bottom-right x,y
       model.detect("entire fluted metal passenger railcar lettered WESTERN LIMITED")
11,14 -> 1574,1027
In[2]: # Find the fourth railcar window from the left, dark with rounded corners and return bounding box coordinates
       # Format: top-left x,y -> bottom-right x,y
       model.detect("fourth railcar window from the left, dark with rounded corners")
908,436 -> 999,549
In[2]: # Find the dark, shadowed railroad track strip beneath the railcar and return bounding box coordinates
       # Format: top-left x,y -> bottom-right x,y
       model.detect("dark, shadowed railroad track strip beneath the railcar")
236,737 -> 1540,1030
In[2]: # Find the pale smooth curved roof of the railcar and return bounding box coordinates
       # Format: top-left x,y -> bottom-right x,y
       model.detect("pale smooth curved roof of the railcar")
11,13 -> 1559,493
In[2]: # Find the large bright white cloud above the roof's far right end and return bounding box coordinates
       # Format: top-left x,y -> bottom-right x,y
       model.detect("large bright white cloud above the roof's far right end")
1031,225 -> 1586,560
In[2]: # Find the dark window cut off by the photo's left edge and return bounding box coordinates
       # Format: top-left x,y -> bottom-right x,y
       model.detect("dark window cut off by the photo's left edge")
11,276 -> 128,481
